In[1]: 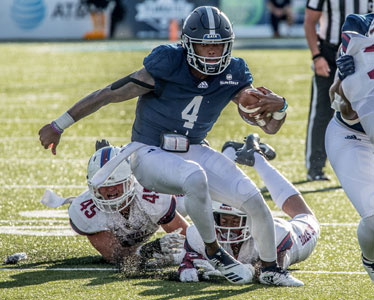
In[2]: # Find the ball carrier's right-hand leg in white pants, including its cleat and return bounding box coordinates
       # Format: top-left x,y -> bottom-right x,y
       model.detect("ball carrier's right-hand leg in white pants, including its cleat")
191,147 -> 303,286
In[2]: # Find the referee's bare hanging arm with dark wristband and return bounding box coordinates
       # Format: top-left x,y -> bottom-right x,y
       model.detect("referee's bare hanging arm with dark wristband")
304,8 -> 330,77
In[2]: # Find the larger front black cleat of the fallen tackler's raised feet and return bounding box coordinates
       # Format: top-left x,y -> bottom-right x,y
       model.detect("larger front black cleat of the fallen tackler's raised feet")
235,133 -> 264,167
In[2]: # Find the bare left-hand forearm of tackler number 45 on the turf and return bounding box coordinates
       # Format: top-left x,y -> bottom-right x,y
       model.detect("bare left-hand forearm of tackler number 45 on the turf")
87,231 -> 136,264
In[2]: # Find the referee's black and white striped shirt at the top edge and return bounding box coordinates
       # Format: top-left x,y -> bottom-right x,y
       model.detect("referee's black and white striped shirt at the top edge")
306,0 -> 374,45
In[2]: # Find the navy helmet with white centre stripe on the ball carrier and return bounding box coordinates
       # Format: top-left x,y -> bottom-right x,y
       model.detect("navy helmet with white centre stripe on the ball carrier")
182,6 -> 235,75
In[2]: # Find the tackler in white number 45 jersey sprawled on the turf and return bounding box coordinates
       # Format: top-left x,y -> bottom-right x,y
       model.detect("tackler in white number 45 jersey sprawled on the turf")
42,146 -> 188,263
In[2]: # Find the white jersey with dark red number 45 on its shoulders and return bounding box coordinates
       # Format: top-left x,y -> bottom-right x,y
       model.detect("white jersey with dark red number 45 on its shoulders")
68,182 -> 176,246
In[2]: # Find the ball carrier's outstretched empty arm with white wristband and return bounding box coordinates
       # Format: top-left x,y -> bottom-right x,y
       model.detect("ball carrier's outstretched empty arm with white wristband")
39,68 -> 155,154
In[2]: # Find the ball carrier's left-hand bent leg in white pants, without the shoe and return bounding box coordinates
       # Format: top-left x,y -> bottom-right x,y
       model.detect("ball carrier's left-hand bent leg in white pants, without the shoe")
131,146 -> 216,243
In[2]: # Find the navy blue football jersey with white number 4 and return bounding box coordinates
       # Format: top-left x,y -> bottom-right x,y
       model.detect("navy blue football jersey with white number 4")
132,44 -> 253,146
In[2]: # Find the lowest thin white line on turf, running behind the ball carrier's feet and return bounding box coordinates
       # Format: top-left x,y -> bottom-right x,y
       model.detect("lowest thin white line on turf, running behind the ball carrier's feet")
0,268 -> 367,275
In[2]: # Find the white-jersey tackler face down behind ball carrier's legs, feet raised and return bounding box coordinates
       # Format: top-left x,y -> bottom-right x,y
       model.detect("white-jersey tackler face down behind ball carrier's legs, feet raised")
179,135 -> 320,281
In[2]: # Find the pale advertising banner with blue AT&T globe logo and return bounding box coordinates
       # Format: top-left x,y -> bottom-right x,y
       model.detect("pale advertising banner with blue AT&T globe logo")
0,0 -> 110,40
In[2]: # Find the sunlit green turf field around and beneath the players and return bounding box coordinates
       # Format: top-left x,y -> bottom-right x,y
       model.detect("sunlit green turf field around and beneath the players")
0,42 -> 374,300
